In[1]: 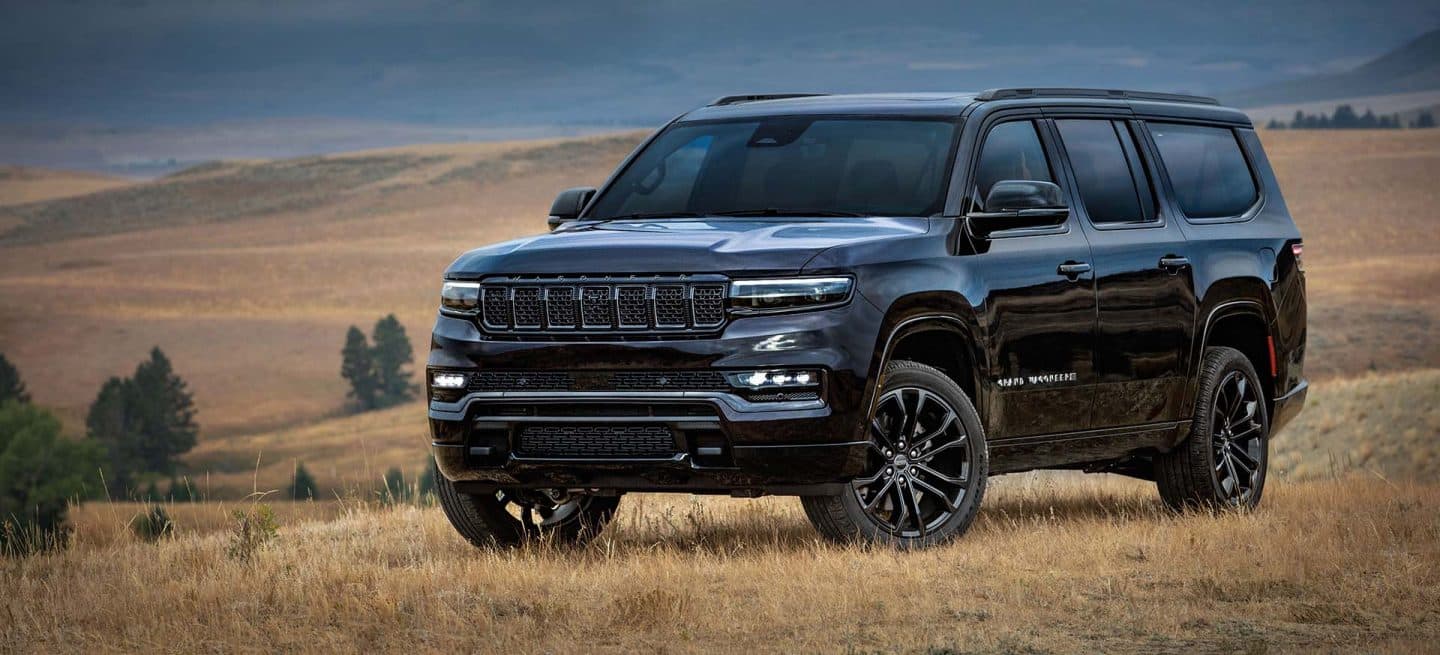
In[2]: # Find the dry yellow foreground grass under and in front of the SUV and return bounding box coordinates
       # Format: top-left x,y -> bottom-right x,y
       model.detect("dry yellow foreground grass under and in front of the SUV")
0,475 -> 1440,652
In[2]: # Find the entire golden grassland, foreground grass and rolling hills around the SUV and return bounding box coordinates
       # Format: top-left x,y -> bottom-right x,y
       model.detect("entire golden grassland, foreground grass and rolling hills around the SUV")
0,130 -> 1440,654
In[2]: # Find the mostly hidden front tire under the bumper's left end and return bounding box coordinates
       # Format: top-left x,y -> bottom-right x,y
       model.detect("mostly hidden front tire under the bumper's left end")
435,460 -> 621,548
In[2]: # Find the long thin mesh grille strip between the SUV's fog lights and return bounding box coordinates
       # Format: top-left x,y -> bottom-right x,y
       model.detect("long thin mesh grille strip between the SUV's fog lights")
469,369 -> 730,392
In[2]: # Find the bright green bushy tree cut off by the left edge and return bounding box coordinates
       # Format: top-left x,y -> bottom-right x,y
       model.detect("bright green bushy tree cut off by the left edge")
0,400 -> 101,553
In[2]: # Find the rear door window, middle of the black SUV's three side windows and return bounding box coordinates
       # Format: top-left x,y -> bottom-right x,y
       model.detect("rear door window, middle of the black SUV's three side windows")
1056,119 -> 1155,225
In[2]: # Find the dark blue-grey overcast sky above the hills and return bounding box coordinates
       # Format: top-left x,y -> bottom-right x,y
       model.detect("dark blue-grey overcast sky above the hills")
0,0 -> 1440,127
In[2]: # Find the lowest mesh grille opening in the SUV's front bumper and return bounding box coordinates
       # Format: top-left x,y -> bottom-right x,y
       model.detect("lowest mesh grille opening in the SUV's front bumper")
516,425 -> 677,458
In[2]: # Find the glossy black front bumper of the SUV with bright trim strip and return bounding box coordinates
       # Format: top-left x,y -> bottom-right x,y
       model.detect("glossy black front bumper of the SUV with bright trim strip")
428,299 -> 881,495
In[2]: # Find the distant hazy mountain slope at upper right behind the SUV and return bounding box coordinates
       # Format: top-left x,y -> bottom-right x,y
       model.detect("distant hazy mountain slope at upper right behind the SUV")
1221,29 -> 1440,108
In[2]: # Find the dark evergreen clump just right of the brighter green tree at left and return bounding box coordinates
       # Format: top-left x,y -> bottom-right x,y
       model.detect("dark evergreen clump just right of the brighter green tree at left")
85,348 -> 200,494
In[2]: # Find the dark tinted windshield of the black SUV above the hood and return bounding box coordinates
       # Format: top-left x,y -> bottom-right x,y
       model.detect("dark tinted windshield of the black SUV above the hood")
589,117 -> 955,219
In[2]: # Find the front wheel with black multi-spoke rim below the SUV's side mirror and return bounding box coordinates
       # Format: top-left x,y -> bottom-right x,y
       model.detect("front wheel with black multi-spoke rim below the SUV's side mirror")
801,361 -> 989,548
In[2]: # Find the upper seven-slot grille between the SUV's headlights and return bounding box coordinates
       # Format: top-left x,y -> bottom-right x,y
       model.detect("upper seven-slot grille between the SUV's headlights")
481,275 -> 726,334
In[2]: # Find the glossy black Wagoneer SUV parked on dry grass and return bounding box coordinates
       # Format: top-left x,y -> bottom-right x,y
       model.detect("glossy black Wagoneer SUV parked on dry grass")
426,89 -> 1306,546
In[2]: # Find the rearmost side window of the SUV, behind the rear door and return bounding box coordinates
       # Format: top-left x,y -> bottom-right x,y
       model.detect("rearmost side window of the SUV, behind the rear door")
1149,122 -> 1260,219
